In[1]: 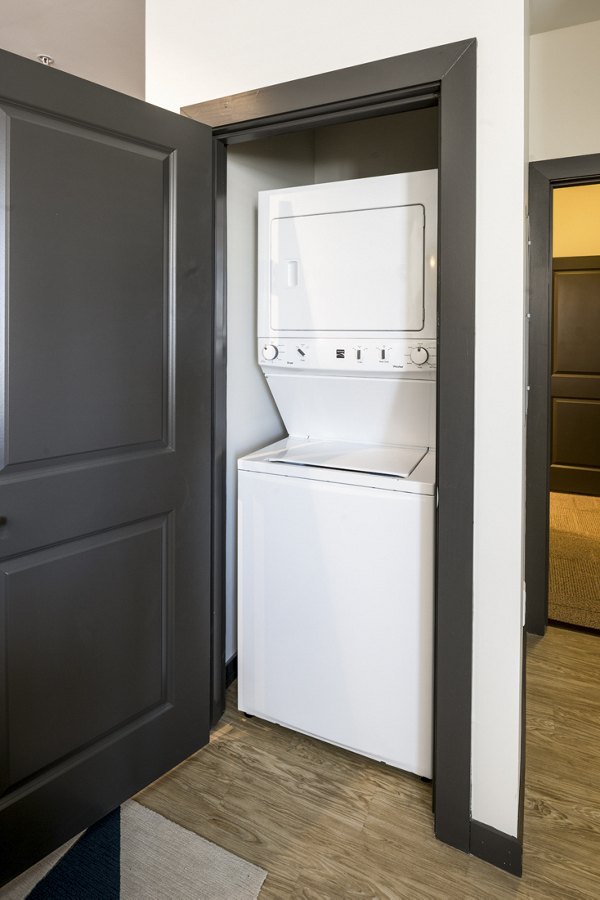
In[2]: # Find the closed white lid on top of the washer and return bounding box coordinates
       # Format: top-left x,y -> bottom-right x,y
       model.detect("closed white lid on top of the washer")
265,441 -> 429,478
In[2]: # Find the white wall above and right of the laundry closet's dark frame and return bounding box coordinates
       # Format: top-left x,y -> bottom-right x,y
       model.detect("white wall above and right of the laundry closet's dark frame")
146,0 -> 526,834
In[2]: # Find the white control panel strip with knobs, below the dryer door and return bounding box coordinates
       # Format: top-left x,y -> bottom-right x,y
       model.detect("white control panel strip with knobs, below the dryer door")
258,338 -> 437,376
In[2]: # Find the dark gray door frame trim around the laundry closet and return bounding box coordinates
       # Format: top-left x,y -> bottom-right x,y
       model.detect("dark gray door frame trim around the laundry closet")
192,40 -> 482,855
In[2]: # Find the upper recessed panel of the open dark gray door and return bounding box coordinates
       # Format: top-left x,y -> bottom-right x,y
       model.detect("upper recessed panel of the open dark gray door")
2,105 -> 174,467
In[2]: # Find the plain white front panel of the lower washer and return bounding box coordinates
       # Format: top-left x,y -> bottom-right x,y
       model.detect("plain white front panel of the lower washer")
238,454 -> 435,778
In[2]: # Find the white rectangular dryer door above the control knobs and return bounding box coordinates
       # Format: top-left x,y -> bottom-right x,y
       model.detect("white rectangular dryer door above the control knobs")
269,204 -> 425,334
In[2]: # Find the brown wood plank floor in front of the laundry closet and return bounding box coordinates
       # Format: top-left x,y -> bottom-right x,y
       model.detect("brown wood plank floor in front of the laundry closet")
137,628 -> 600,900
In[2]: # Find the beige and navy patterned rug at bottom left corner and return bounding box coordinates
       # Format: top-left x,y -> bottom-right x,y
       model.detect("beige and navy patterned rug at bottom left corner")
0,800 -> 267,900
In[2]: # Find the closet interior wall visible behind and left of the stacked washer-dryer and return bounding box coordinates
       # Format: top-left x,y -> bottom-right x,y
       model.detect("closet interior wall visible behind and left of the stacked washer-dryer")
225,107 -> 438,661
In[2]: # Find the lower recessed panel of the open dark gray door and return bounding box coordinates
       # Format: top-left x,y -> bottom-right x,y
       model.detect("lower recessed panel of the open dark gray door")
0,516 -> 173,788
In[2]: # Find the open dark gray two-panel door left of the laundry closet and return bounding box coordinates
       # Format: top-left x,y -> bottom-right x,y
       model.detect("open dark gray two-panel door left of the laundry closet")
0,53 -> 212,883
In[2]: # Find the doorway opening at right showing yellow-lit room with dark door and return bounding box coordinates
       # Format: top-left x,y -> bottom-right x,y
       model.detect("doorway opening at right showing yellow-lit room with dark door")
548,184 -> 600,632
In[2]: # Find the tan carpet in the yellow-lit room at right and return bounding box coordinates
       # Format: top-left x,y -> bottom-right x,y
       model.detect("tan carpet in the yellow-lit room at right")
548,492 -> 600,630
